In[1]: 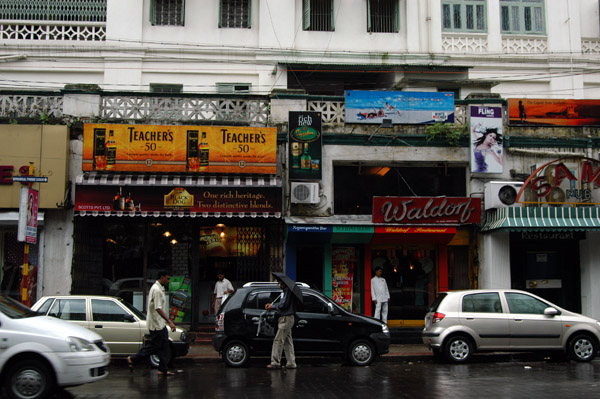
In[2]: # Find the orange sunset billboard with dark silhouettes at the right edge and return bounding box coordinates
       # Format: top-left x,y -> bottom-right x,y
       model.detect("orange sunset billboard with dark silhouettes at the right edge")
508,98 -> 600,126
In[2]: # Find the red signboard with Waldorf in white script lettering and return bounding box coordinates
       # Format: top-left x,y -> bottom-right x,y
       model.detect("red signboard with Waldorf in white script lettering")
373,197 -> 481,225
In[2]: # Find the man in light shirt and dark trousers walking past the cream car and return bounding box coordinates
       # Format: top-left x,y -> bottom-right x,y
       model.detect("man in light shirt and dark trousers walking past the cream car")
127,271 -> 175,376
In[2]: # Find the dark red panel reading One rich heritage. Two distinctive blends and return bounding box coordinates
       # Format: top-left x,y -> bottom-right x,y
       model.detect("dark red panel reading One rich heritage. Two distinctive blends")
75,185 -> 281,213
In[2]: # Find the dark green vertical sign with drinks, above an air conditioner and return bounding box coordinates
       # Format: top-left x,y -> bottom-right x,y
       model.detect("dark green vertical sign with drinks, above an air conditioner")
288,111 -> 323,180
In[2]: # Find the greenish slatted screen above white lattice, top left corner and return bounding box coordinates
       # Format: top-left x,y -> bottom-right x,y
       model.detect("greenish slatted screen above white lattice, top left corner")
0,0 -> 106,22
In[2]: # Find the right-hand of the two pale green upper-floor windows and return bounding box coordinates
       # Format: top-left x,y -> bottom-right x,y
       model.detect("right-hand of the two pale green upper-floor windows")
500,0 -> 546,35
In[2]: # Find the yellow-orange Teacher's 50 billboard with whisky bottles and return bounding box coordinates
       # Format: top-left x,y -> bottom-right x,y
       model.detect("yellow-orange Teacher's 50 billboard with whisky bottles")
82,124 -> 277,174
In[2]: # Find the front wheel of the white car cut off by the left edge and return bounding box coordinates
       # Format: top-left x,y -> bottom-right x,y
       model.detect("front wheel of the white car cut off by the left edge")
4,359 -> 54,399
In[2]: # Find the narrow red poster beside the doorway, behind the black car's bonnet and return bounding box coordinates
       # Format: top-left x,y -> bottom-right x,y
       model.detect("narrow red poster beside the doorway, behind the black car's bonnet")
331,247 -> 355,312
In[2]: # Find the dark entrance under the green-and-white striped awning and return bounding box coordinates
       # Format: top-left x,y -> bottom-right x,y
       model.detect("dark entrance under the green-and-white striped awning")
510,232 -> 581,312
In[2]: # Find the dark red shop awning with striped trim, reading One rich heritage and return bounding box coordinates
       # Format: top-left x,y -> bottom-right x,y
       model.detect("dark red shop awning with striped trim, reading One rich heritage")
75,172 -> 282,218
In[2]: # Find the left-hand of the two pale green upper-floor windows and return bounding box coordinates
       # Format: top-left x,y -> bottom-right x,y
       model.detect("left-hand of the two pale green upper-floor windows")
442,0 -> 486,32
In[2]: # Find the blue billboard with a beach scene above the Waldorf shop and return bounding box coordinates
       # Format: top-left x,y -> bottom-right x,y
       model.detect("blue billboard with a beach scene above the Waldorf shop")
346,90 -> 454,124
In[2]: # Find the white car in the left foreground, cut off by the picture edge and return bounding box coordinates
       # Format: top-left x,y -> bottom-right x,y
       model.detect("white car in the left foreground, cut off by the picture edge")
0,296 -> 110,399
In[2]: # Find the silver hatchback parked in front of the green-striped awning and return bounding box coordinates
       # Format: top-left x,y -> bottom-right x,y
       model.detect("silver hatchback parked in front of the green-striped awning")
422,289 -> 600,363
